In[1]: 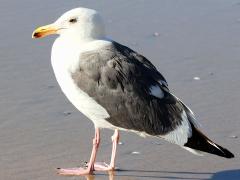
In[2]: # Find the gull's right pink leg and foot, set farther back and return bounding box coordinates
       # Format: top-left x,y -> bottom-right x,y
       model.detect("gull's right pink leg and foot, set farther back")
94,129 -> 119,171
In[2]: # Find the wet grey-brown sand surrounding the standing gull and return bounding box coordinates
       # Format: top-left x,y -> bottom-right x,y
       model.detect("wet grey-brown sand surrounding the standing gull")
0,0 -> 240,180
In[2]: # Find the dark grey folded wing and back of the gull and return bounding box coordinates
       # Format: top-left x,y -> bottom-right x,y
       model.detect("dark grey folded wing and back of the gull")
72,42 -> 186,135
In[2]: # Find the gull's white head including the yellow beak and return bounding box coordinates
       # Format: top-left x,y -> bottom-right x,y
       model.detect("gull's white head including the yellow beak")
32,7 -> 105,41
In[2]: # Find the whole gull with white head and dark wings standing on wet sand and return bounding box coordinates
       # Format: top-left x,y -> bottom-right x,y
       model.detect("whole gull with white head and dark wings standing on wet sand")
32,7 -> 234,175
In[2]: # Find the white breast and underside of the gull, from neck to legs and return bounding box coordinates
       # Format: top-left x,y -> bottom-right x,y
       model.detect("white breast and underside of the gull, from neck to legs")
51,38 -> 113,128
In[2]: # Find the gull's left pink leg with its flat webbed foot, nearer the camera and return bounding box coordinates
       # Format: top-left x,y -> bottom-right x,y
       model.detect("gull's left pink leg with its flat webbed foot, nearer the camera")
58,128 -> 100,176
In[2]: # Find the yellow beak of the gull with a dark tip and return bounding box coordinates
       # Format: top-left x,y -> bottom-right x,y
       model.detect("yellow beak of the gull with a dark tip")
32,24 -> 58,38
